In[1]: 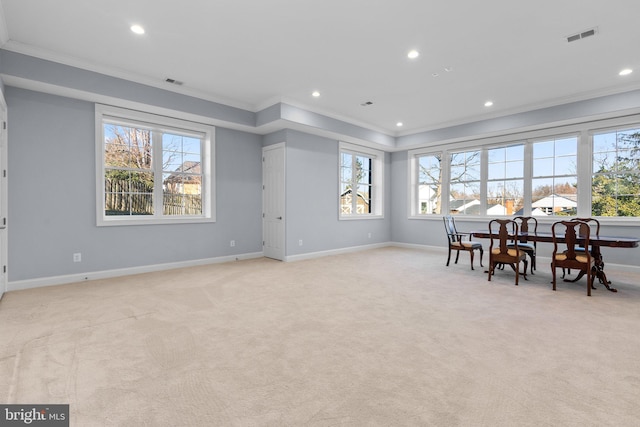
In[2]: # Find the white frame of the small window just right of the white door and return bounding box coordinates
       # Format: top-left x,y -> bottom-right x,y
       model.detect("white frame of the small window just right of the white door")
337,141 -> 384,220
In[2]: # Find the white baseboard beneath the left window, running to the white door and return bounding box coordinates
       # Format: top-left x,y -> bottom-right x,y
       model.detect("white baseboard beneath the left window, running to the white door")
7,252 -> 264,291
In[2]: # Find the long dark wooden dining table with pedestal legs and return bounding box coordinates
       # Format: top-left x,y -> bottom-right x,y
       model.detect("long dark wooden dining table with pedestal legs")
470,230 -> 640,292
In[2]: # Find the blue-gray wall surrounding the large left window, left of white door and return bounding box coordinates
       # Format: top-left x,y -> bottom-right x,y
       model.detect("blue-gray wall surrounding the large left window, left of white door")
6,87 -> 262,281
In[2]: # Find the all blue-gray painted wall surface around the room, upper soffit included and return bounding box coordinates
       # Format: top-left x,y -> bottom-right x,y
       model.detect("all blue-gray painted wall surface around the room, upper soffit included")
0,49 -> 640,282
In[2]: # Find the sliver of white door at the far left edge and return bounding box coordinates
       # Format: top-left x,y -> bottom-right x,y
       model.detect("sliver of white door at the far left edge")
0,97 -> 8,298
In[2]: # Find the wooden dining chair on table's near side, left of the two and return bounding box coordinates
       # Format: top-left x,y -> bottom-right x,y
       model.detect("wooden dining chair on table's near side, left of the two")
488,219 -> 527,286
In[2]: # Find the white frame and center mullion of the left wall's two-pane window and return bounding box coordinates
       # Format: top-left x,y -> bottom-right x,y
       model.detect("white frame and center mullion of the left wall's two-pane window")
95,104 -> 216,226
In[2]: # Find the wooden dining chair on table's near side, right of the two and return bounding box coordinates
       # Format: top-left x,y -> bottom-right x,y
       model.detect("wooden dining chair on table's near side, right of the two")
551,220 -> 594,296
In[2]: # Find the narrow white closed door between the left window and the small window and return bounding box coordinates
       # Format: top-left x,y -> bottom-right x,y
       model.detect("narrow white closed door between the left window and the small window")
262,143 -> 286,261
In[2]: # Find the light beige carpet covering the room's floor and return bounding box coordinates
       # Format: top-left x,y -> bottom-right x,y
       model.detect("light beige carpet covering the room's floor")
0,248 -> 640,426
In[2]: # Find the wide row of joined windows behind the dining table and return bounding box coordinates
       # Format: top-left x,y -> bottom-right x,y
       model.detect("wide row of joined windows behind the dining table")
408,115 -> 640,219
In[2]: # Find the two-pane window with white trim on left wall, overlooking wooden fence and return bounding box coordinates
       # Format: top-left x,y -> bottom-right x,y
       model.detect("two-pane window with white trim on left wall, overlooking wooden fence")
96,105 -> 215,225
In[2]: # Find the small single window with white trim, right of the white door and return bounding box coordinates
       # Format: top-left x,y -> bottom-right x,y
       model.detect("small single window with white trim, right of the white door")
339,142 -> 384,219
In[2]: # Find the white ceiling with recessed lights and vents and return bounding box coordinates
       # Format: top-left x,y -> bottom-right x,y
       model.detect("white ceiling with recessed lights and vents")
0,0 -> 640,135
